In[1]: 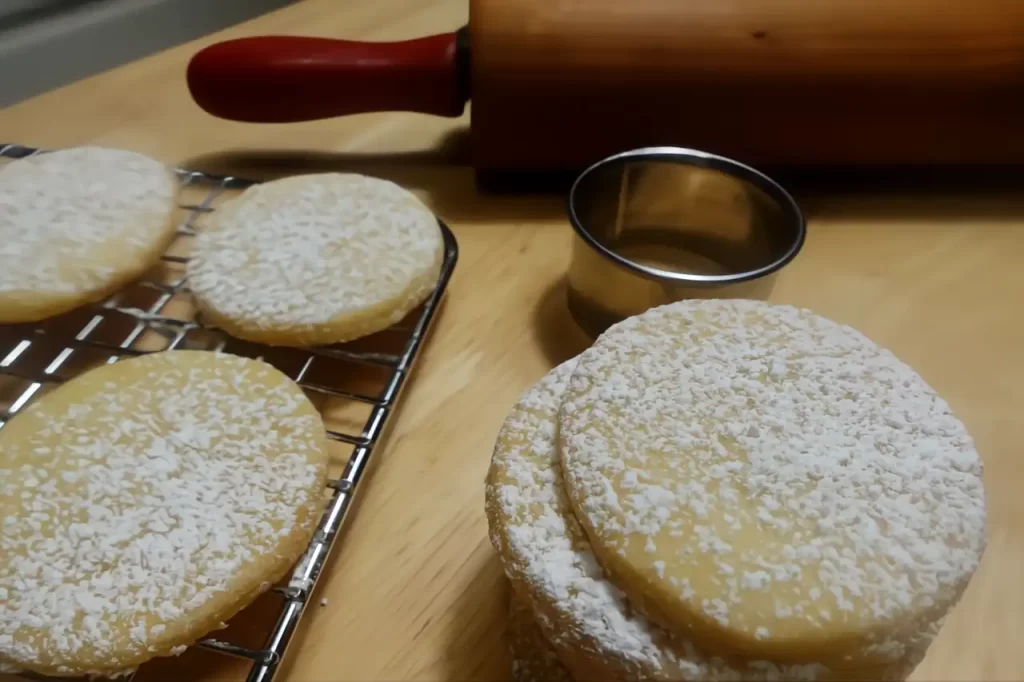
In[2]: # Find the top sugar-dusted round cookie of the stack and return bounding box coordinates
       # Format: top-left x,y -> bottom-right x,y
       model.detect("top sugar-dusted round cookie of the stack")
559,300 -> 986,666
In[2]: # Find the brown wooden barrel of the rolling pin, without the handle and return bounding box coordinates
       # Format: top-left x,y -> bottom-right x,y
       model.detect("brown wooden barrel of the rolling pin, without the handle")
470,0 -> 1024,169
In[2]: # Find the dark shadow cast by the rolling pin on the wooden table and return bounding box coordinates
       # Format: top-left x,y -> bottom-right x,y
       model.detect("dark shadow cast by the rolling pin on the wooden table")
182,146 -> 1024,225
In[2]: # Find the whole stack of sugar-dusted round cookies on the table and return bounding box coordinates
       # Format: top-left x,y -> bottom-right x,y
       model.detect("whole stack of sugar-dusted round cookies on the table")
486,300 -> 986,681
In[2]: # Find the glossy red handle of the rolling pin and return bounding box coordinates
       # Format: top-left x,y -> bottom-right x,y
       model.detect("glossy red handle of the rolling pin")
187,31 -> 469,123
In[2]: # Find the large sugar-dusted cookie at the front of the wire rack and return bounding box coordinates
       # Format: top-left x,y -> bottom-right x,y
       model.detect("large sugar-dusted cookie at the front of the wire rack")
0,350 -> 327,676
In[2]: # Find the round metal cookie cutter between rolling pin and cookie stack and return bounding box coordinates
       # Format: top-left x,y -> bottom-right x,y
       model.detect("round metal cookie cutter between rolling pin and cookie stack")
568,146 -> 806,335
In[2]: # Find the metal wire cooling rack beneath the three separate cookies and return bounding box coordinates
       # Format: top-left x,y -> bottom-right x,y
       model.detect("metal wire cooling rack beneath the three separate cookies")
0,143 -> 458,682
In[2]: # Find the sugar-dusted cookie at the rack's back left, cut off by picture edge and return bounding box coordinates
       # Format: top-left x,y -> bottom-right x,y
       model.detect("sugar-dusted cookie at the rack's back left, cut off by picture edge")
0,146 -> 178,323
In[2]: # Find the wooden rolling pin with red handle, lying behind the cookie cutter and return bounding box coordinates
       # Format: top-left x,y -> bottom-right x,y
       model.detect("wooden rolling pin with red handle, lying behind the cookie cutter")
187,0 -> 1024,170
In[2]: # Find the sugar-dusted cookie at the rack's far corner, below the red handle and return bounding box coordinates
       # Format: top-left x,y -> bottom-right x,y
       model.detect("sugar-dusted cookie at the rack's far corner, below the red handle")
187,173 -> 444,346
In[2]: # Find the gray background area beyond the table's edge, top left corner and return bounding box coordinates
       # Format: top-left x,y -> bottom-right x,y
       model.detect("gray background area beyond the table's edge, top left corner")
0,0 -> 288,106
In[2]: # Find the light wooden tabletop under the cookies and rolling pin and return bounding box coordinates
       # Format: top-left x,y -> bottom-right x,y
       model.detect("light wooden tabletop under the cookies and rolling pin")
0,0 -> 1024,682
